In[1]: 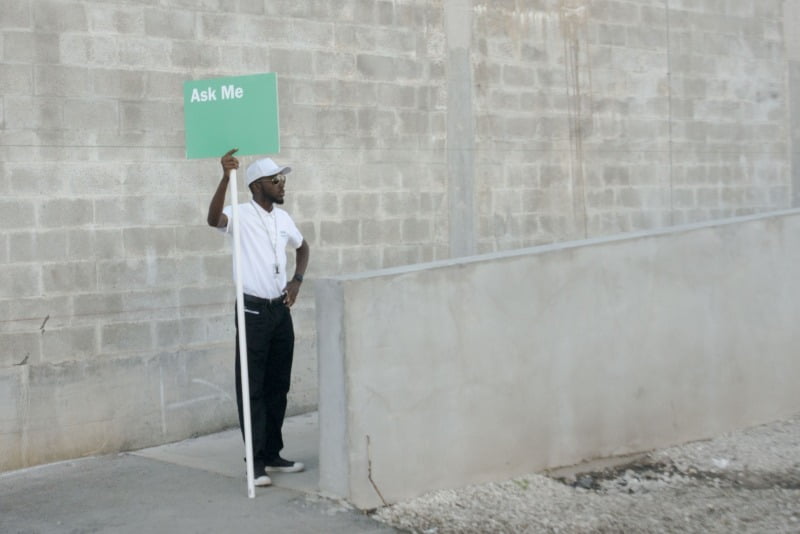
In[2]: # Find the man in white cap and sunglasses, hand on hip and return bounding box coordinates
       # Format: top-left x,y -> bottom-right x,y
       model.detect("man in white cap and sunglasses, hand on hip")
208,148 -> 309,486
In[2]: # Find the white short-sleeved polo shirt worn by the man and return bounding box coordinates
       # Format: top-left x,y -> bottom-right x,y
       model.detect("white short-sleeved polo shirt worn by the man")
220,200 -> 303,299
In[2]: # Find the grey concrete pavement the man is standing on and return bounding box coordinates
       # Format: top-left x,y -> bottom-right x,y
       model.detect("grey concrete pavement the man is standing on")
0,413 -> 397,534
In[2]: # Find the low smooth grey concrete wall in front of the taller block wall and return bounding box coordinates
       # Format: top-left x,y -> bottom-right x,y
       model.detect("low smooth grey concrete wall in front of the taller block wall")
317,211 -> 800,508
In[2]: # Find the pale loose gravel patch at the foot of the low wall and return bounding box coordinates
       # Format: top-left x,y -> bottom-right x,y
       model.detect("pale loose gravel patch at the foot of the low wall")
373,414 -> 800,534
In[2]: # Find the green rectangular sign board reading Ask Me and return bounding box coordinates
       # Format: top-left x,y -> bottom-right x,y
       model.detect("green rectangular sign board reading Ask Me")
183,72 -> 280,159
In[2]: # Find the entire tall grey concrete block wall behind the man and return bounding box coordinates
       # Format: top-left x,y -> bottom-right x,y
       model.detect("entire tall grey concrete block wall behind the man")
0,0 -> 800,470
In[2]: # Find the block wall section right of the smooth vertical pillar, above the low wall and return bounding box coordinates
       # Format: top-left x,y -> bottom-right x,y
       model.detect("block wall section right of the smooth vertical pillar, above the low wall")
472,0 -> 797,252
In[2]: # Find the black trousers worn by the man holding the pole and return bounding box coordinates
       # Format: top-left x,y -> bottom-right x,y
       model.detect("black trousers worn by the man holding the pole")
236,295 -> 294,466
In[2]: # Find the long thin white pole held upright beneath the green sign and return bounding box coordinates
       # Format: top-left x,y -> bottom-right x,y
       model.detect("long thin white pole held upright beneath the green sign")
230,169 -> 256,499
